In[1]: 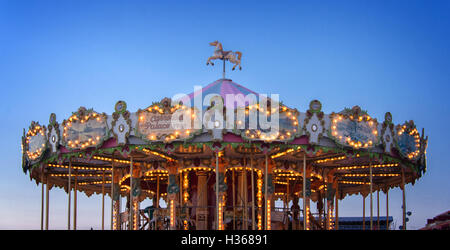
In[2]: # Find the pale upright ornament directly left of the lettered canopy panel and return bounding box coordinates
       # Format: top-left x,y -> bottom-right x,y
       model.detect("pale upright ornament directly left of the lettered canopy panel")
111,101 -> 131,145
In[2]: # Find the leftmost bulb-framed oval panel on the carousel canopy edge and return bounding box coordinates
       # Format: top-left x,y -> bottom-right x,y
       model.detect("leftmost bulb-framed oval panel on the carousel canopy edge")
24,121 -> 47,161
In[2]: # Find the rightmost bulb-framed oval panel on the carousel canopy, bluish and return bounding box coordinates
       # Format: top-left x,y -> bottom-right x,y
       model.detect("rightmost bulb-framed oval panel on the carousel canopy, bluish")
395,121 -> 420,160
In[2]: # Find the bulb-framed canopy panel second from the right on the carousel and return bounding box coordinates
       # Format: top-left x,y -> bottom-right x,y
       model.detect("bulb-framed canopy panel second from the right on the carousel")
330,106 -> 378,149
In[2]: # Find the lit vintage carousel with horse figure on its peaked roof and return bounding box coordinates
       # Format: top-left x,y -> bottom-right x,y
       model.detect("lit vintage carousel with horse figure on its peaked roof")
22,41 -> 428,230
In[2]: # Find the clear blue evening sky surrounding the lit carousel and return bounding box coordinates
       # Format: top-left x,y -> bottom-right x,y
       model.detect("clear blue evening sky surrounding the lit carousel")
0,0 -> 450,229
